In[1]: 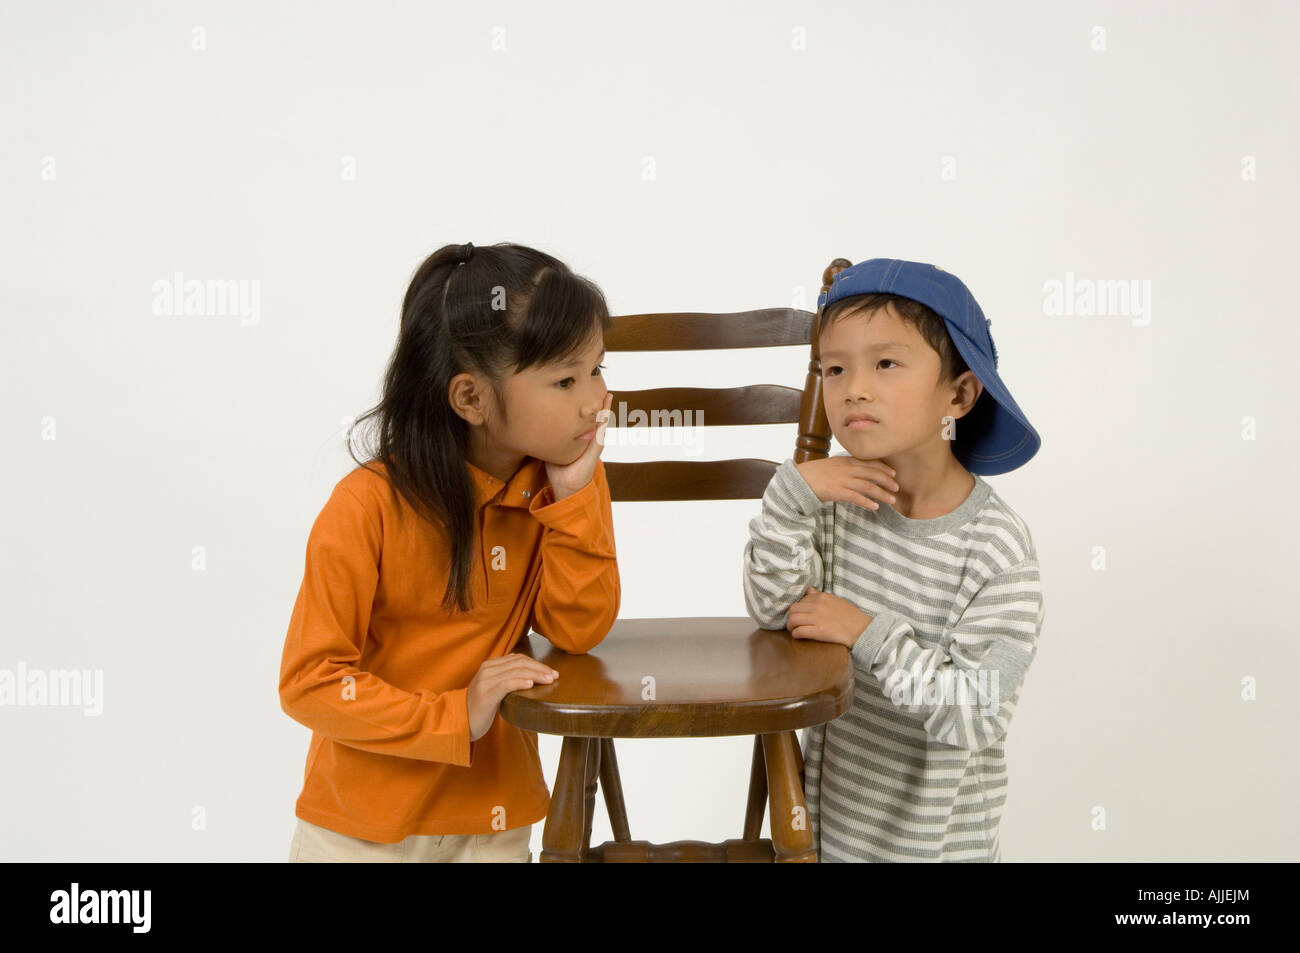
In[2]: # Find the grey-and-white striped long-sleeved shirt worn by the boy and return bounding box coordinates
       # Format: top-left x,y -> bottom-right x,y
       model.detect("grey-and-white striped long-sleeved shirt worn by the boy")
744,459 -> 1044,862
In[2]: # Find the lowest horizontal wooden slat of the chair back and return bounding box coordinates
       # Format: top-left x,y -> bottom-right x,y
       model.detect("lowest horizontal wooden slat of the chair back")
605,458 -> 779,503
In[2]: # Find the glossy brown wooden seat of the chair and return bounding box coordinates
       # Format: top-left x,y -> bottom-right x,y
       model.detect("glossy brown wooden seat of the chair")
501,616 -> 853,738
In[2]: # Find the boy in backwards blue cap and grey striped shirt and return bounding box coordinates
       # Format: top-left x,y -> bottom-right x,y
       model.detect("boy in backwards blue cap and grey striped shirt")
744,259 -> 1044,862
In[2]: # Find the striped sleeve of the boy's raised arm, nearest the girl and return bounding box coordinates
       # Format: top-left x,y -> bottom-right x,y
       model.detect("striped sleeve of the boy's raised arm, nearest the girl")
744,459 -> 823,629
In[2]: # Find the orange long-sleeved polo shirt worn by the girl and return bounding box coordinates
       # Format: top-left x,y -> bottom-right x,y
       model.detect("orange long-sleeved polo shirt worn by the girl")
280,458 -> 620,844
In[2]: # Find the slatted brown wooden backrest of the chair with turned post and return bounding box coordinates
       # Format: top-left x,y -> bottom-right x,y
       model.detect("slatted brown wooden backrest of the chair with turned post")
605,259 -> 852,502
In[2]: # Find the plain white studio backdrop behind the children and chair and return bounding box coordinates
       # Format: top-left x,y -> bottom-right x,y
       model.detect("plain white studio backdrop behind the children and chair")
0,1 -> 1300,861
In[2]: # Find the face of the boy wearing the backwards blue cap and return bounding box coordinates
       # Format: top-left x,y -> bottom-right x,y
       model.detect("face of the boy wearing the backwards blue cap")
820,304 -> 980,460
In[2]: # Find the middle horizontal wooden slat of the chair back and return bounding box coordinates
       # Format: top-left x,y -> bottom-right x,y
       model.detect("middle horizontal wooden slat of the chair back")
610,384 -> 803,428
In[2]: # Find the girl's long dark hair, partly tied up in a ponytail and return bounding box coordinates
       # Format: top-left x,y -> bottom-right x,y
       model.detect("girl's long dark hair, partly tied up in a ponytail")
347,243 -> 610,611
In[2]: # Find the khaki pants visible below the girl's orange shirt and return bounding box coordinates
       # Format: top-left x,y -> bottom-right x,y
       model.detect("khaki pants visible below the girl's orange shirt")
289,818 -> 533,863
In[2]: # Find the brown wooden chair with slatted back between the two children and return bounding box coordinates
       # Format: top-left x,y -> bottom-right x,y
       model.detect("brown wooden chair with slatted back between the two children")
501,259 -> 853,862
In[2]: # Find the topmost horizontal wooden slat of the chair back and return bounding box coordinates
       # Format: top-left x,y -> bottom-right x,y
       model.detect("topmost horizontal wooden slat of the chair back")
605,308 -> 814,351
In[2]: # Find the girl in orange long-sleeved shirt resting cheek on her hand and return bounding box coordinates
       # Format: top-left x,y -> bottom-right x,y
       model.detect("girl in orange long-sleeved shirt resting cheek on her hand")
280,244 -> 620,862
